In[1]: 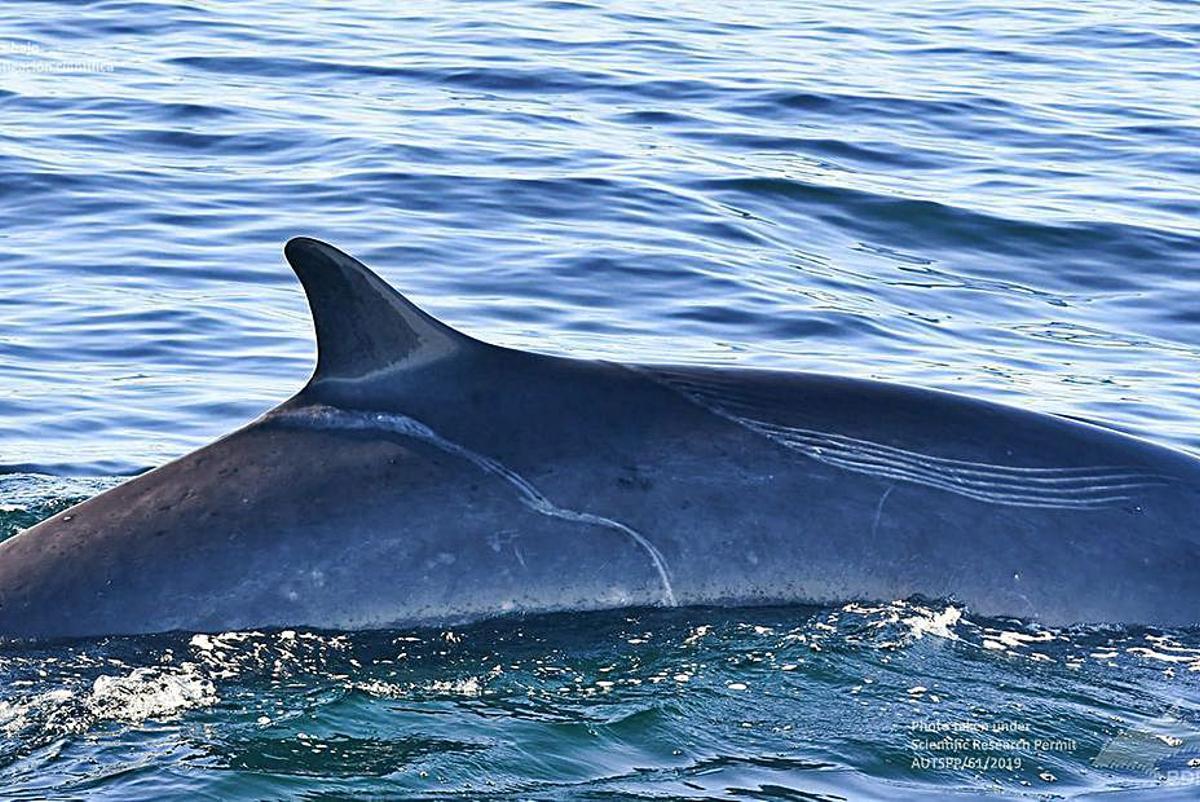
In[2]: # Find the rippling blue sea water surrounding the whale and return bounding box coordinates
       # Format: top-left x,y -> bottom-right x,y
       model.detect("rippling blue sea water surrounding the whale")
0,0 -> 1200,801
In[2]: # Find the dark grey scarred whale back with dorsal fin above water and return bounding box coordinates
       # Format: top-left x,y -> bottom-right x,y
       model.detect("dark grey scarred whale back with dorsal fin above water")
0,239 -> 1200,638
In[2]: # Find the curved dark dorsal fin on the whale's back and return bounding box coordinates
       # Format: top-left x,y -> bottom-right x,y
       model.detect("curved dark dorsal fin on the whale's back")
283,237 -> 482,382
